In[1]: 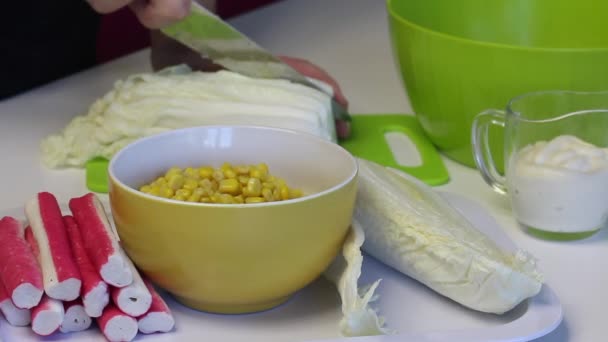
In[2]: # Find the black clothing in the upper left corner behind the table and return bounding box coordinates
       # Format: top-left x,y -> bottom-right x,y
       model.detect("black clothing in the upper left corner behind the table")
0,0 -> 99,99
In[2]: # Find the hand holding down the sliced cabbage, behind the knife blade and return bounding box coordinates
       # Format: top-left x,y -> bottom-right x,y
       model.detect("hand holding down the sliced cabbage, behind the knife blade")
279,56 -> 350,139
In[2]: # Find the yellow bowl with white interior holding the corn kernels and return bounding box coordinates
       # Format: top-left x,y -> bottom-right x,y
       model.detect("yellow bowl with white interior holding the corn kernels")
109,126 -> 358,313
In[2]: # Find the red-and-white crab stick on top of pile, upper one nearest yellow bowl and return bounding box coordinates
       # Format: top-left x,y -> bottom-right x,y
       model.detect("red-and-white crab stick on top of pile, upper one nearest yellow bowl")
69,193 -> 133,287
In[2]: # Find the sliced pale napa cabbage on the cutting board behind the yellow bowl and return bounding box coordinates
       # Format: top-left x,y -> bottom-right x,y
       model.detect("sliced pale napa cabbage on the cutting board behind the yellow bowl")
41,65 -> 336,168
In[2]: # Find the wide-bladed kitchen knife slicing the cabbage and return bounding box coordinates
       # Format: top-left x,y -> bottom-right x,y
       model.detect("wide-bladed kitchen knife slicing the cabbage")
161,1 -> 351,121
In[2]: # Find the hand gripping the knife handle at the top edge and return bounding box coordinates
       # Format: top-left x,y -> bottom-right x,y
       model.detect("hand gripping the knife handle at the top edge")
87,0 -> 192,29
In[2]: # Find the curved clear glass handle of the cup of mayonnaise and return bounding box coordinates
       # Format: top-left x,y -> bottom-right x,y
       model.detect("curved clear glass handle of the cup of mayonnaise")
471,109 -> 507,194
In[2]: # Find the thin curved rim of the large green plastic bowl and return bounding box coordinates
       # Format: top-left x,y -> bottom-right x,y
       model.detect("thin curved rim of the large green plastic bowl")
386,0 -> 608,53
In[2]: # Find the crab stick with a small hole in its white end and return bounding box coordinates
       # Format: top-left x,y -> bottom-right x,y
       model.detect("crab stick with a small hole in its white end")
111,252 -> 152,317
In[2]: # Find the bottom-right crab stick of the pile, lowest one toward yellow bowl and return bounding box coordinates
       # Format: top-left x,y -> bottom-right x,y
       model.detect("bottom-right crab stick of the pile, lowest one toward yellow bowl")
137,280 -> 175,334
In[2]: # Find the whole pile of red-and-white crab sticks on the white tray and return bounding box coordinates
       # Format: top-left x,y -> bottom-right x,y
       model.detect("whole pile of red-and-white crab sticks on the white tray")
0,192 -> 175,341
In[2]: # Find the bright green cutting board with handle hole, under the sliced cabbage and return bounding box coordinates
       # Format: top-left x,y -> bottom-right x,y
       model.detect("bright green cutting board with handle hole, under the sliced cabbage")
86,114 -> 450,193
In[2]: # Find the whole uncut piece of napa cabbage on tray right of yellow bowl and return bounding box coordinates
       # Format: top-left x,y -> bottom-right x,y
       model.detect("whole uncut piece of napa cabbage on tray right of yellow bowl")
353,159 -> 544,314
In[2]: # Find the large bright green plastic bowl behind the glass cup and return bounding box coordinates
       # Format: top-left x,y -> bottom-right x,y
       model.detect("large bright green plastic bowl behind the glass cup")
387,0 -> 608,169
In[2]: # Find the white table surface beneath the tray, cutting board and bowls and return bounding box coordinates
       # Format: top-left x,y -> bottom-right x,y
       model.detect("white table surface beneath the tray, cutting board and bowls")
0,0 -> 608,341
